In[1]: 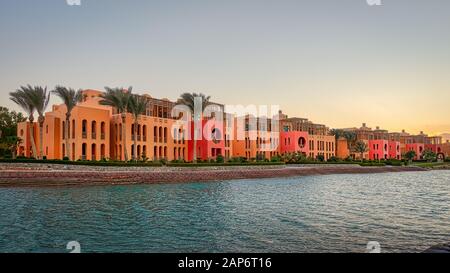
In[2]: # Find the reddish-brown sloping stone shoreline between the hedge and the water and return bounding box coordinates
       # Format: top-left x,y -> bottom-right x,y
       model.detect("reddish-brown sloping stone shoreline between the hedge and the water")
0,163 -> 429,188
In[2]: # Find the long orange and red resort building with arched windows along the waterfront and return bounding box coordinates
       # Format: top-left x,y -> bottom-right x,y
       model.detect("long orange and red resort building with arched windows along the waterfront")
17,90 -> 450,161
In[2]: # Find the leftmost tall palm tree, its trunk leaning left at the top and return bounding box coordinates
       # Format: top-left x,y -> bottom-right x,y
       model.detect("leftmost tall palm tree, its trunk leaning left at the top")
9,86 -> 37,157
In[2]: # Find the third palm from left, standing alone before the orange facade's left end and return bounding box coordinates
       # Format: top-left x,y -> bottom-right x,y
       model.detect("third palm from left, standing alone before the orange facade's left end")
52,86 -> 83,157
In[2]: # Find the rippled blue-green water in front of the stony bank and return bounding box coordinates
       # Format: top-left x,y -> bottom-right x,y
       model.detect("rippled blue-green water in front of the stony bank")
0,171 -> 450,253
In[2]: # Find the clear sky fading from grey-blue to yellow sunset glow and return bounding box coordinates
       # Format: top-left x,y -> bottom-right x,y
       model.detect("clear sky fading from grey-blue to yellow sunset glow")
0,0 -> 450,134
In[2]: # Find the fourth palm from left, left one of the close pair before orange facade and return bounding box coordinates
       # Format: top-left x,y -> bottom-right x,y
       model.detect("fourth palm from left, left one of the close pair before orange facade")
100,86 -> 133,162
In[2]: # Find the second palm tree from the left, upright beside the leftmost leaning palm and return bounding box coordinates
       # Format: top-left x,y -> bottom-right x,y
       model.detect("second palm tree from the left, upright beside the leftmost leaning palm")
28,86 -> 50,159
